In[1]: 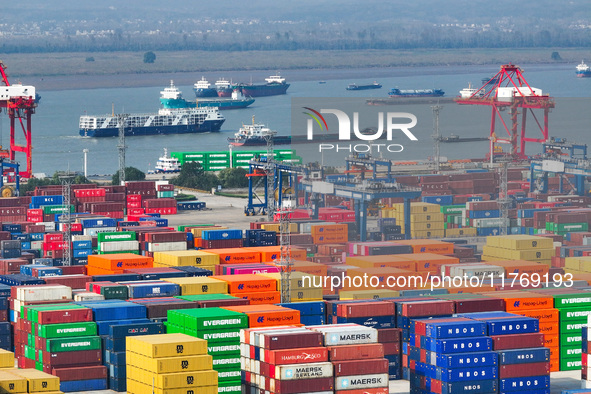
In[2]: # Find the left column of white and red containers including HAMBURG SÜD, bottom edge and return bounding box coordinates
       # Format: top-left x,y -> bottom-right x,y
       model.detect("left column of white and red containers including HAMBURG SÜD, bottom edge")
240,326 -> 333,394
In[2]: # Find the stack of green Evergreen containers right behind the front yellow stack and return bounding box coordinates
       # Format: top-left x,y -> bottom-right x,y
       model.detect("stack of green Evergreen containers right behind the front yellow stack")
166,307 -> 248,394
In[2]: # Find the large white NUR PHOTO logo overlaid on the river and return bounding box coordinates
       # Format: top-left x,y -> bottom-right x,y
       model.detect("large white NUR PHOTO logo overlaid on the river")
302,107 -> 418,153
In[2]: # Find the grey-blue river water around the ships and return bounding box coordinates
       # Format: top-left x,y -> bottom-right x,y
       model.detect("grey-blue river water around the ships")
0,64 -> 591,175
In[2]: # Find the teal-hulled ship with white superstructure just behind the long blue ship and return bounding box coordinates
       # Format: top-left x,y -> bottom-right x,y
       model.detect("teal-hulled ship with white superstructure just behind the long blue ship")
160,81 -> 254,109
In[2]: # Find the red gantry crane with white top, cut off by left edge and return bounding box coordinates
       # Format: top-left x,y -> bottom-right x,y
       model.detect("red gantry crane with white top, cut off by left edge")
0,61 -> 37,178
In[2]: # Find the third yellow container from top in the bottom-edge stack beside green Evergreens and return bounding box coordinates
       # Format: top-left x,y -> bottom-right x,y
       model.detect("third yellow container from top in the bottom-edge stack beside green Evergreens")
127,365 -> 218,393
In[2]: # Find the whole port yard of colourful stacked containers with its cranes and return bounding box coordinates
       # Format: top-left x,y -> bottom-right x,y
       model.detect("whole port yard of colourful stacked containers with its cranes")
0,55 -> 591,394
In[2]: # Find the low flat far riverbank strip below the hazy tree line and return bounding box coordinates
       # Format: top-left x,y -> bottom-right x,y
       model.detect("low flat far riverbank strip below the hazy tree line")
0,48 -> 589,92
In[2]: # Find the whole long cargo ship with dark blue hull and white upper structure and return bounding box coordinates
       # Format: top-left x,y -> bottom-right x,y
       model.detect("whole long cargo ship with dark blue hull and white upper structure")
79,107 -> 226,138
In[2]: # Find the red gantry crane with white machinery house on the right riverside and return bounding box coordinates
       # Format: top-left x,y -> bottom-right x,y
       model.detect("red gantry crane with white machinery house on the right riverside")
455,64 -> 554,160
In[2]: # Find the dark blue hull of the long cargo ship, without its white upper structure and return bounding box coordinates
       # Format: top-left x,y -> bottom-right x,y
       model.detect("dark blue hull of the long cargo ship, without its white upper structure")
79,119 -> 225,138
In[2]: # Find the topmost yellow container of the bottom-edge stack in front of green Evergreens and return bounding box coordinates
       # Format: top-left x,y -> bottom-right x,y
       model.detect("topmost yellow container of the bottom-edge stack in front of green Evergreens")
126,334 -> 207,358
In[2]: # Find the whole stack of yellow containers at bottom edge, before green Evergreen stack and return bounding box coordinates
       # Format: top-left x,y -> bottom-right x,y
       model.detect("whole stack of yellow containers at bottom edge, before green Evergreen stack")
127,334 -> 218,394
